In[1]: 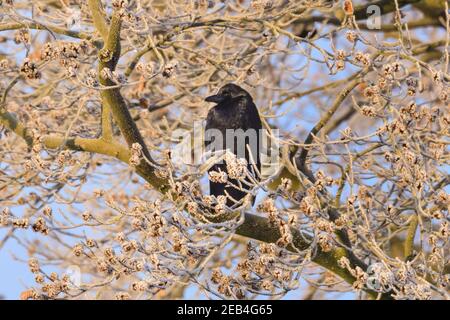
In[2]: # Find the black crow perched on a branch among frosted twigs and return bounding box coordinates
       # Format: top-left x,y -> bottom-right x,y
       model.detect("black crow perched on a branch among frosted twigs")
205,83 -> 262,207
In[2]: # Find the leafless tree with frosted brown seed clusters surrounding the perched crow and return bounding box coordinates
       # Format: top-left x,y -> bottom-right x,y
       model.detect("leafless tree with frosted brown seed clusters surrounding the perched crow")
0,0 -> 450,299
